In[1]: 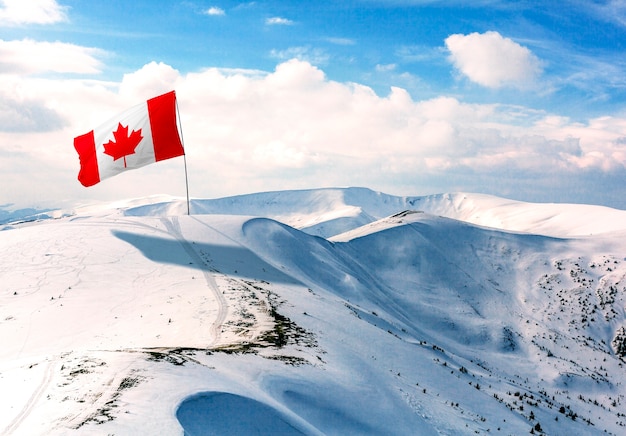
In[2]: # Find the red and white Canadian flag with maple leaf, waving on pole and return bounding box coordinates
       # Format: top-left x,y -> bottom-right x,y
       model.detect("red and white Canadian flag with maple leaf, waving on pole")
74,91 -> 185,186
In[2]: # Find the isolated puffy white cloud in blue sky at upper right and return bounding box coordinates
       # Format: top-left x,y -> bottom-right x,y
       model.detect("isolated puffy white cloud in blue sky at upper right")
445,32 -> 542,88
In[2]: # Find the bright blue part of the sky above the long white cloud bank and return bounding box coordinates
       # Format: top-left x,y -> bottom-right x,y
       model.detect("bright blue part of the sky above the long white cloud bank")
37,0 -> 626,119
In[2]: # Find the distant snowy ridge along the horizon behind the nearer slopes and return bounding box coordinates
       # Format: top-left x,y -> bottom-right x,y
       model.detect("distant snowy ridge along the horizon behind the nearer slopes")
127,188 -> 626,237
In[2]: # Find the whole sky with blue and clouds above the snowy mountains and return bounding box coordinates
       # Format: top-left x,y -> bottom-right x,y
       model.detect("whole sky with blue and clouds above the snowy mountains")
0,0 -> 626,208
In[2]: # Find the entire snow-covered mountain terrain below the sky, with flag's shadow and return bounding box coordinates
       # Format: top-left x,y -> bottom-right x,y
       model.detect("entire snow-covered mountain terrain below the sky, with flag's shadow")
0,188 -> 626,435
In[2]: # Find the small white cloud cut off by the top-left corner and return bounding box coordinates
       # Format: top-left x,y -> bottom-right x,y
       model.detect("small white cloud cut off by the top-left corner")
0,0 -> 67,25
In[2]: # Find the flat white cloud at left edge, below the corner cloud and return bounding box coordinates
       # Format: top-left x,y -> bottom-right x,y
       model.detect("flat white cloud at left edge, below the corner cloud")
0,39 -> 104,74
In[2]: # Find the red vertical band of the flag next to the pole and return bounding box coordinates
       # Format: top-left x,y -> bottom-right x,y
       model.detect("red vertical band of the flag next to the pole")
148,91 -> 185,162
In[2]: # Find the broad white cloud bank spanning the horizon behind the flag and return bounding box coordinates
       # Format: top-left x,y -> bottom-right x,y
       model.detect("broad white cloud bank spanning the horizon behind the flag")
0,59 -> 626,207
